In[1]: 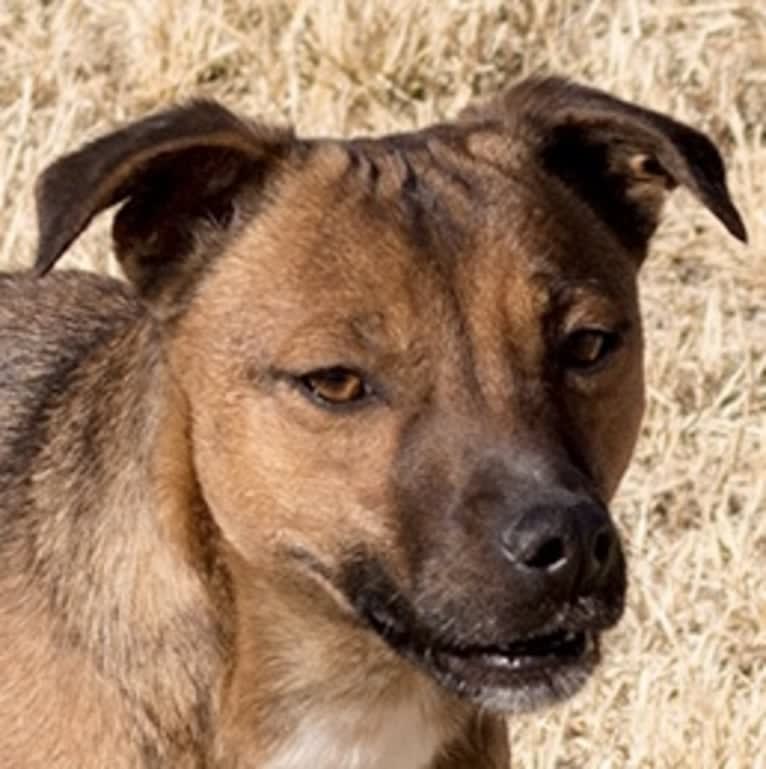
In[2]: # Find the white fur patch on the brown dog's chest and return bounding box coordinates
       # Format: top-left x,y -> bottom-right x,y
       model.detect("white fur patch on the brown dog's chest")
263,703 -> 445,769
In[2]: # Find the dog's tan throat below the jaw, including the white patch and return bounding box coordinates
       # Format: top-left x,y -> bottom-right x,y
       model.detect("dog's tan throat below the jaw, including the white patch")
207,544 -> 468,769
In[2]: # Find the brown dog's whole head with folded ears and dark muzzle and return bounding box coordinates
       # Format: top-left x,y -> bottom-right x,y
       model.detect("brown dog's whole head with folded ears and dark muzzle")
38,79 -> 745,711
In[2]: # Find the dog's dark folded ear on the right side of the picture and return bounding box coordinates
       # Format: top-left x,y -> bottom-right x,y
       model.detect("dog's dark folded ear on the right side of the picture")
464,77 -> 747,256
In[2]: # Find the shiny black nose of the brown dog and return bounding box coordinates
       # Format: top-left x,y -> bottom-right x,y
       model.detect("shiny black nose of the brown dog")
501,498 -> 619,596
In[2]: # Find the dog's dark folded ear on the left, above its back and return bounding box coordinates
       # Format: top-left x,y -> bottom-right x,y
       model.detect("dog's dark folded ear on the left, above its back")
35,101 -> 294,304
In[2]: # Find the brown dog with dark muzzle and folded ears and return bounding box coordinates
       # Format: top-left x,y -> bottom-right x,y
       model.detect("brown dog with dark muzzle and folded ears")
0,73 -> 746,769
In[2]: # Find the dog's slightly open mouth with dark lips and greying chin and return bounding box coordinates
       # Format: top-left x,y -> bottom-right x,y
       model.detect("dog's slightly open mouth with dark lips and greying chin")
292,553 -> 622,713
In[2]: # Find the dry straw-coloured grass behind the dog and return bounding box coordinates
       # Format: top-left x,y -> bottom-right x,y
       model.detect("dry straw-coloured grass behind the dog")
0,0 -> 766,769
